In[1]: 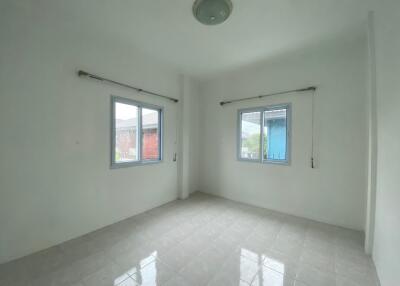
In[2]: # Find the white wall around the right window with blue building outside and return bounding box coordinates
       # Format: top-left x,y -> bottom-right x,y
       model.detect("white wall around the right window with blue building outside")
199,36 -> 368,230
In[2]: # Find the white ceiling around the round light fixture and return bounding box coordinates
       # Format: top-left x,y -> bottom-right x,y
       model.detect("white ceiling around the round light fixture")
43,0 -> 367,77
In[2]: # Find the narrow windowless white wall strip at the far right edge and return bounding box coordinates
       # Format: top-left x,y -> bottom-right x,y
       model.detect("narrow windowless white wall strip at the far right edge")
373,0 -> 400,286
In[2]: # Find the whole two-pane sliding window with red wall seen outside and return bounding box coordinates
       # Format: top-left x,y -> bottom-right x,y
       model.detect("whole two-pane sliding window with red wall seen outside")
111,97 -> 162,167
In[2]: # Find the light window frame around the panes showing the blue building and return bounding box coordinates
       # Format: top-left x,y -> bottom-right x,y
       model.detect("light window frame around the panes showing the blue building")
236,103 -> 292,165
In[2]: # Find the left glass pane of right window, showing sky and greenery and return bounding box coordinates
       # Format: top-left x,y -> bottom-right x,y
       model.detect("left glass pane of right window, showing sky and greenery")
240,111 -> 261,160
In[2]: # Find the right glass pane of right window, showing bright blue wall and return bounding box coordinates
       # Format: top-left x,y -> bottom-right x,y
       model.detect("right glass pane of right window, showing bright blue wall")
263,108 -> 287,161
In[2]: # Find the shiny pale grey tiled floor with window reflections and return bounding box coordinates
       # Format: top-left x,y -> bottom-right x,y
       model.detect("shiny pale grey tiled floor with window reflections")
0,193 -> 376,286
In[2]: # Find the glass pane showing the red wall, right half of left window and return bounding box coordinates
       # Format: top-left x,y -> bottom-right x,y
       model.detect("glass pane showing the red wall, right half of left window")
142,108 -> 160,160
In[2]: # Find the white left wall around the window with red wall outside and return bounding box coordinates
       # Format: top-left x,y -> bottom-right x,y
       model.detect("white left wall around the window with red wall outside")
0,1 -> 195,263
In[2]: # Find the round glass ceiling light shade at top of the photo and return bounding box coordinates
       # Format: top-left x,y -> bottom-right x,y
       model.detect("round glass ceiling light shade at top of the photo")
193,0 -> 232,25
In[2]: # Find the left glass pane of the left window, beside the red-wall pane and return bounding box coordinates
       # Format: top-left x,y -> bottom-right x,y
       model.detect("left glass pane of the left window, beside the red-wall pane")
115,102 -> 139,163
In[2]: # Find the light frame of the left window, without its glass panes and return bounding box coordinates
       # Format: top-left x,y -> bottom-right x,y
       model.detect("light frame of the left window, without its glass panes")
111,96 -> 164,169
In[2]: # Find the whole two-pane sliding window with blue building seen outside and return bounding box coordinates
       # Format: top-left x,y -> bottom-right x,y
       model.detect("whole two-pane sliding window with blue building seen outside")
238,104 -> 290,164
